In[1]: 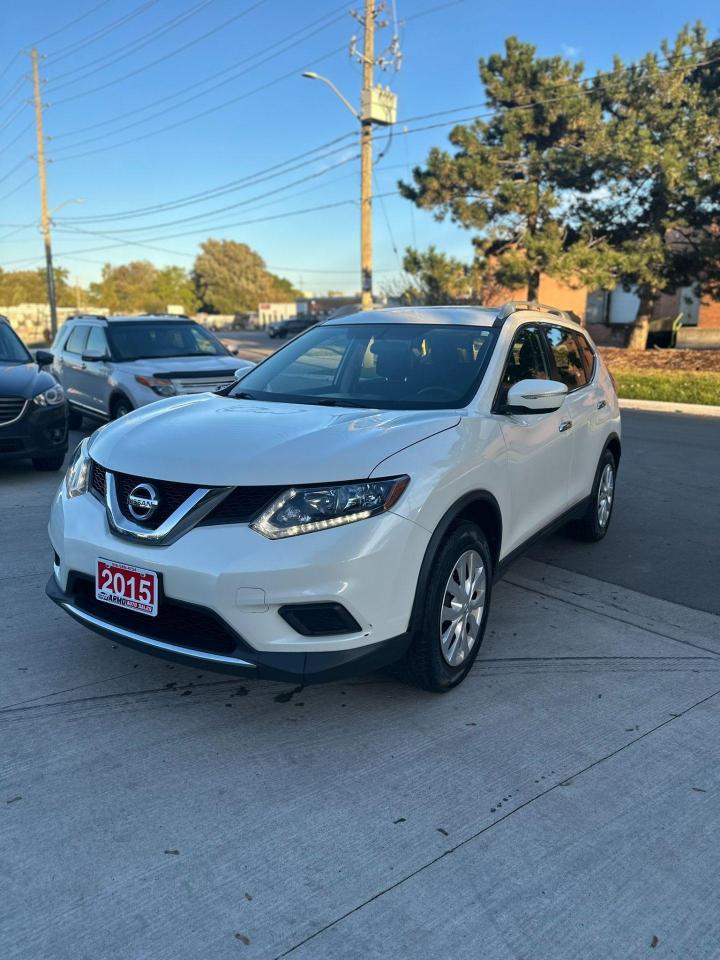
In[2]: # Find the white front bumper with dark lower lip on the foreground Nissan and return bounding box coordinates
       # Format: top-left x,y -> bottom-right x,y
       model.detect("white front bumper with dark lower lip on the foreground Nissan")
48,487 -> 429,683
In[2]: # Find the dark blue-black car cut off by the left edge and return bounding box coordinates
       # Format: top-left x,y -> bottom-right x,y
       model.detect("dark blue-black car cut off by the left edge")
0,317 -> 68,470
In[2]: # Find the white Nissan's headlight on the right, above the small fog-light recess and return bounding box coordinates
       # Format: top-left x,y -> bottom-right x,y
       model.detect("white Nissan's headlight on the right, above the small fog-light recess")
250,477 -> 410,540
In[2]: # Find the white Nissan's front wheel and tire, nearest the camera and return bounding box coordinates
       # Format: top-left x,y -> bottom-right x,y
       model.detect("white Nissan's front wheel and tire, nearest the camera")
395,522 -> 492,693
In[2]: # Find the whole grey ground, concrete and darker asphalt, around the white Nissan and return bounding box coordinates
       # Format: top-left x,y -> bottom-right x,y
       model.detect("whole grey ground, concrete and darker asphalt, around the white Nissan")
0,414 -> 720,960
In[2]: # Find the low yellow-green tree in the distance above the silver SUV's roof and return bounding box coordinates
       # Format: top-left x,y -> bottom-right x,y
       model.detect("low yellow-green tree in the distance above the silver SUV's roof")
90,260 -> 198,313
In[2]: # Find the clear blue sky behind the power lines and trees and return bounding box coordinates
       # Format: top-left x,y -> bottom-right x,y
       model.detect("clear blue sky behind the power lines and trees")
0,0 -> 720,293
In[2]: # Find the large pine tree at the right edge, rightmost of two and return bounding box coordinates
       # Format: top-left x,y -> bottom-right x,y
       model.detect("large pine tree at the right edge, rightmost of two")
578,24 -> 720,347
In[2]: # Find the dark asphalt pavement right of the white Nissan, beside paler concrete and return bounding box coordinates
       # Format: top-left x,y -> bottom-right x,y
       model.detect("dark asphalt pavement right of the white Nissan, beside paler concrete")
530,410 -> 720,613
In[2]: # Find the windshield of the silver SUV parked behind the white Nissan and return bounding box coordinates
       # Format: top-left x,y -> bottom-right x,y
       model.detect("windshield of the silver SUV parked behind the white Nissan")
108,320 -> 229,360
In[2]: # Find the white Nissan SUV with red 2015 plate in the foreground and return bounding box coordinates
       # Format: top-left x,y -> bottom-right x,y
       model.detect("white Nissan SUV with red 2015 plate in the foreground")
48,303 -> 620,690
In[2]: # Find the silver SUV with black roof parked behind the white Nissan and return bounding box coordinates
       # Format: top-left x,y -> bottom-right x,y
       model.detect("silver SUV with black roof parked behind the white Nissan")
53,314 -> 254,428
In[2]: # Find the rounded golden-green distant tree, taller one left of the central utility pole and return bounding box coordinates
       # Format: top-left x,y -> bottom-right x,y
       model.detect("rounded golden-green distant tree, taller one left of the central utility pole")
193,239 -> 299,314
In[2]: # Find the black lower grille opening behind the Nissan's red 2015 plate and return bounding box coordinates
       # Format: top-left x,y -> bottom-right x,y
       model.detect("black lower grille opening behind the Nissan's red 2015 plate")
68,574 -> 238,654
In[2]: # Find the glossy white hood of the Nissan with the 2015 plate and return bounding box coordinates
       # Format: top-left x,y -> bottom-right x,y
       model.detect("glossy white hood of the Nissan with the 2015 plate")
90,394 -> 460,486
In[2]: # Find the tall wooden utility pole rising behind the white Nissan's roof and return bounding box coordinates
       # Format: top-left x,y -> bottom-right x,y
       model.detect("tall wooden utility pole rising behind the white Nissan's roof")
360,0 -> 375,310
